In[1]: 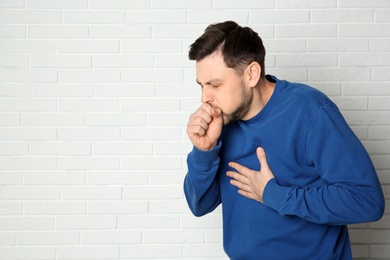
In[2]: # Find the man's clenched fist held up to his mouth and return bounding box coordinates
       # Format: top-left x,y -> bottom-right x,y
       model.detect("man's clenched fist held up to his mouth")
187,103 -> 223,151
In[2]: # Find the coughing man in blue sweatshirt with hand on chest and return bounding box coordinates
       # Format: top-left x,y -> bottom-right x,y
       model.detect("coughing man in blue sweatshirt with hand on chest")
184,21 -> 384,260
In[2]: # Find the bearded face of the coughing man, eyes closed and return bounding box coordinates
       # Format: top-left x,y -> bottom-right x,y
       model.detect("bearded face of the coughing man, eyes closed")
196,51 -> 253,125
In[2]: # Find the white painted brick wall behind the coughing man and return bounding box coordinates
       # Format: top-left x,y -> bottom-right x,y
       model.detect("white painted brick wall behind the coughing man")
0,0 -> 390,260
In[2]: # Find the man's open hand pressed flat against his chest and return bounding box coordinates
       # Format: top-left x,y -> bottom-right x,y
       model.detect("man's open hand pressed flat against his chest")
226,147 -> 275,203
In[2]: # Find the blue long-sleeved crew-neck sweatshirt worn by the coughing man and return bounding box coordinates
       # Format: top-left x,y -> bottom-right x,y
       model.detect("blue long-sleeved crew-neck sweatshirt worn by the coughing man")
184,76 -> 384,260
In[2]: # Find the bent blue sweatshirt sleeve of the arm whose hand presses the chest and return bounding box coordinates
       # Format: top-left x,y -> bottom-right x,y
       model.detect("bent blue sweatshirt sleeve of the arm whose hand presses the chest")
263,103 -> 384,225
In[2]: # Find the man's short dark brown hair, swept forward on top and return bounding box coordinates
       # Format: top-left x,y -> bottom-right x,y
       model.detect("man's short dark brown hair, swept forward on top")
188,21 -> 265,78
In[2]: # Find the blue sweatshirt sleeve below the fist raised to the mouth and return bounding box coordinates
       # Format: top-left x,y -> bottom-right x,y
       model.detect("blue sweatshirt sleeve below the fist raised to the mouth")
184,141 -> 221,216
